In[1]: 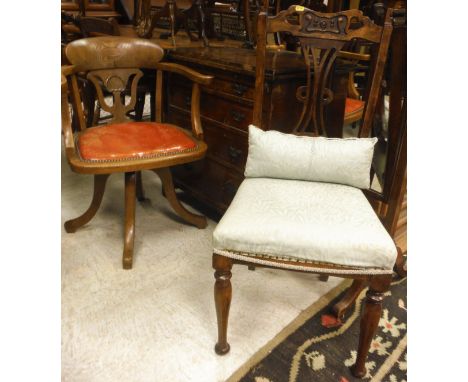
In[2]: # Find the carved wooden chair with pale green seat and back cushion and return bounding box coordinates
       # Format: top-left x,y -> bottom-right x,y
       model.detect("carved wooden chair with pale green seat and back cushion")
213,6 -> 397,377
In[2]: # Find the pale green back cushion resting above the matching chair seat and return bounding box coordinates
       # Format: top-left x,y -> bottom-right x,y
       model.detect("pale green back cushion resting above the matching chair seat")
245,125 -> 377,189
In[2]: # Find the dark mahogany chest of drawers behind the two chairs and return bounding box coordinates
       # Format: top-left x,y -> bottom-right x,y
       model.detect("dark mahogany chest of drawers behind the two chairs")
165,47 -> 347,213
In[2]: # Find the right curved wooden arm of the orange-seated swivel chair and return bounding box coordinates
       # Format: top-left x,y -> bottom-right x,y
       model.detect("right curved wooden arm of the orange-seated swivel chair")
155,62 -> 213,139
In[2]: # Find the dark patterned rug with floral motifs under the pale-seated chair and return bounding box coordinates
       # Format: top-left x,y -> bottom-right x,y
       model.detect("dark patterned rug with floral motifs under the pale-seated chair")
228,279 -> 407,382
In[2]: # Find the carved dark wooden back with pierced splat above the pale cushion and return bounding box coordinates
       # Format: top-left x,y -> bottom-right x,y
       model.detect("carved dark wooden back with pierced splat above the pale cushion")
253,5 -> 392,137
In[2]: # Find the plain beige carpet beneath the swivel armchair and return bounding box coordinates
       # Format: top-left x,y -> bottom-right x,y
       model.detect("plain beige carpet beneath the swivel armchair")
62,144 -> 340,382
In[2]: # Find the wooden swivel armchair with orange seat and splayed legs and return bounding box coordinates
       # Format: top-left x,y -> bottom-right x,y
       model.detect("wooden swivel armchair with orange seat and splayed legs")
62,37 -> 212,269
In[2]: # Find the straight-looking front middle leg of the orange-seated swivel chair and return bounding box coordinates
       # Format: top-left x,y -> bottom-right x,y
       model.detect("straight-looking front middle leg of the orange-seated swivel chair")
122,172 -> 136,269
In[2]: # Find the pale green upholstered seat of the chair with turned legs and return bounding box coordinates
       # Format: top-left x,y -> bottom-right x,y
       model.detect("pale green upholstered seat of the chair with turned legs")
213,178 -> 397,272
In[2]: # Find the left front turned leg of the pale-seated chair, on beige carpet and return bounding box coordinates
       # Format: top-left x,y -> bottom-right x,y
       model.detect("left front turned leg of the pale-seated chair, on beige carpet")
213,254 -> 232,355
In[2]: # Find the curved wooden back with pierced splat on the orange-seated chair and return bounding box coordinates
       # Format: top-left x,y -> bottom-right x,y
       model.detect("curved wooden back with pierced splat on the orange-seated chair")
66,36 -> 164,130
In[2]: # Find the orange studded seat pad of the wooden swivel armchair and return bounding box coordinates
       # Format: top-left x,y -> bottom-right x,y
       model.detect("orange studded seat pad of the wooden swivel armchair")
78,122 -> 197,160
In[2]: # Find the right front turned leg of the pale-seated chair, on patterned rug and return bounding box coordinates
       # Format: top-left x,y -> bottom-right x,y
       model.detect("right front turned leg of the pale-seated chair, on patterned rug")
351,275 -> 392,378
